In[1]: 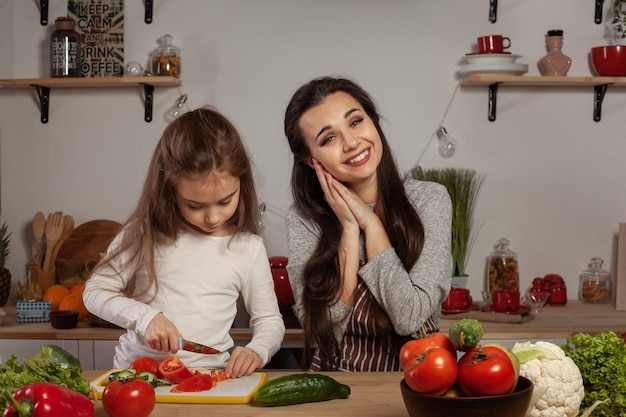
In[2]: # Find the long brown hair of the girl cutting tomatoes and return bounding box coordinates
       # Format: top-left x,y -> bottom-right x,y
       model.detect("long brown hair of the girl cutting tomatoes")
93,107 -> 257,288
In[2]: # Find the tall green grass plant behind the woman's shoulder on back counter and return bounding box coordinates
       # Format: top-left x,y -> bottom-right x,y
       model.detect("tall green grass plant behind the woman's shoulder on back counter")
407,166 -> 485,287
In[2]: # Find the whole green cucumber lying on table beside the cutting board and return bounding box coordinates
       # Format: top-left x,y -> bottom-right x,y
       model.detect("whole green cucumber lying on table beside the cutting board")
254,373 -> 350,407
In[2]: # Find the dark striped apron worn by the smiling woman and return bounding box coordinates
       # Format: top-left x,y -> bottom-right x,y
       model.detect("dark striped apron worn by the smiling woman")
311,279 -> 439,372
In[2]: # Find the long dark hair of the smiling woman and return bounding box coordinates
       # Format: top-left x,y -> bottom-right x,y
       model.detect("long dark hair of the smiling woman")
284,77 -> 424,369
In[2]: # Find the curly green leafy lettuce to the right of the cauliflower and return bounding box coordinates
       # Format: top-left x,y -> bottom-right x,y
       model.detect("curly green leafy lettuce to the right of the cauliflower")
561,332 -> 626,417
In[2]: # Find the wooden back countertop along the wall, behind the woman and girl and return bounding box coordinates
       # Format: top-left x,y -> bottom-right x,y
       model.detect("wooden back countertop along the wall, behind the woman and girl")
0,300 -> 626,345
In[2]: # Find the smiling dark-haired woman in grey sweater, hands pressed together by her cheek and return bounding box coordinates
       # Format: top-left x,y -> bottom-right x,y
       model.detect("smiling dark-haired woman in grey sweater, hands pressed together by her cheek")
285,77 -> 452,371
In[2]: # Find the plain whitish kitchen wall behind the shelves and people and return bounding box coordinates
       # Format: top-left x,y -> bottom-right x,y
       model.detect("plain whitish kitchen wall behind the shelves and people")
0,0 -> 626,298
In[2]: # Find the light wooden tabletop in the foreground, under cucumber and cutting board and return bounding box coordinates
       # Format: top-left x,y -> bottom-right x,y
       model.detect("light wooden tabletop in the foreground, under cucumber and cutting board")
80,371 -> 409,417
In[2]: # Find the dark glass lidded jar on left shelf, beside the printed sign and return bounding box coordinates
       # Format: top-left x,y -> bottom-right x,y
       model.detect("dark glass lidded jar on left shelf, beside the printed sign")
50,16 -> 81,78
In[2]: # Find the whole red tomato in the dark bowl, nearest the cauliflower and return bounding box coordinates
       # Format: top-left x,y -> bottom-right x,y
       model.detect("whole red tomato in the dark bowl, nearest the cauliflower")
458,346 -> 516,397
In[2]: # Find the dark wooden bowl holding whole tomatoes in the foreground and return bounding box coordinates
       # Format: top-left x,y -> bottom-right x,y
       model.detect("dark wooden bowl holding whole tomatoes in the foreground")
400,376 -> 533,417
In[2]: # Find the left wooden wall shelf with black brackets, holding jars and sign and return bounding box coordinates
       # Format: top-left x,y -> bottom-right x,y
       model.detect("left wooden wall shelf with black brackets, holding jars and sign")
0,77 -> 182,123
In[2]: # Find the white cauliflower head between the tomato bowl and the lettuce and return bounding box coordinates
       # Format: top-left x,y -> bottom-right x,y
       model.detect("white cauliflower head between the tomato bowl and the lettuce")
513,342 -> 585,417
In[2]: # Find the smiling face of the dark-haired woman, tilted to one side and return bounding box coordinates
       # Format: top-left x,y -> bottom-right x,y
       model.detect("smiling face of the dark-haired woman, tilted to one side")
300,92 -> 383,185
